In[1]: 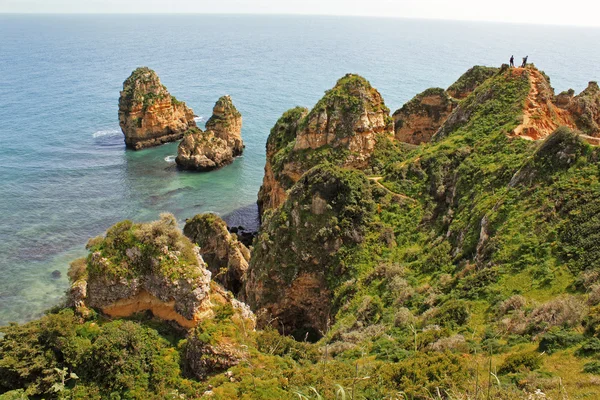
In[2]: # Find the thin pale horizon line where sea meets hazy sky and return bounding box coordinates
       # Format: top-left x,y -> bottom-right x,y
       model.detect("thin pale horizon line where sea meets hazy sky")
0,11 -> 600,29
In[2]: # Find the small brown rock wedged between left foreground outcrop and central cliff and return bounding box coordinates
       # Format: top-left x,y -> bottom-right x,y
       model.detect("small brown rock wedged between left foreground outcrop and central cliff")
183,214 -> 250,295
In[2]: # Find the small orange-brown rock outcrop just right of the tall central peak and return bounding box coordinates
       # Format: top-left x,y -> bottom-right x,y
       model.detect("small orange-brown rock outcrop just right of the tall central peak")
393,88 -> 458,145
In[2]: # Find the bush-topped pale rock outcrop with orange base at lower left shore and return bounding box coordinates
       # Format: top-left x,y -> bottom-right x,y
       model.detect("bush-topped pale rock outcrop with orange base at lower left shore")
69,214 -> 253,328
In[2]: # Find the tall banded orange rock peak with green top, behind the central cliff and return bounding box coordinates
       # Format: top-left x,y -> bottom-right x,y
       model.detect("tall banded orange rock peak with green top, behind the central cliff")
258,74 -> 393,219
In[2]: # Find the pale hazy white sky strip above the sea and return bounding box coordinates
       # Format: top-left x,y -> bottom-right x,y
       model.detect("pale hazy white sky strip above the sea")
0,0 -> 600,26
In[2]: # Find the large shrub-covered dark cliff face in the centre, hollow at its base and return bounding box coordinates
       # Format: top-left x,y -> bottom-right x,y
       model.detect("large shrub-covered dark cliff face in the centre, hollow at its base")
246,164 -> 374,339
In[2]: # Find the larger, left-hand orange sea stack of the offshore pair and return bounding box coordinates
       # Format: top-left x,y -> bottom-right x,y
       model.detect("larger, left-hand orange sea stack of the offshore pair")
119,67 -> 196,150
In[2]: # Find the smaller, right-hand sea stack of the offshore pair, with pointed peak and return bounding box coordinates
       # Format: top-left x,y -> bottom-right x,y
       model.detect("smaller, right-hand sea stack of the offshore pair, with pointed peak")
175,96 -> 244,171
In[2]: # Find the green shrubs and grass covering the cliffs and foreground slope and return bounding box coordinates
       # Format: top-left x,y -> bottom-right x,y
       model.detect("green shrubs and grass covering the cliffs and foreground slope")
0,70 -> 600,400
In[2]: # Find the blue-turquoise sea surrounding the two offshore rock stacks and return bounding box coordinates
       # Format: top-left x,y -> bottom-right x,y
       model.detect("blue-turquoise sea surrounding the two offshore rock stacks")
0,16 -> 600,325
